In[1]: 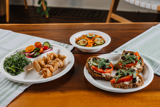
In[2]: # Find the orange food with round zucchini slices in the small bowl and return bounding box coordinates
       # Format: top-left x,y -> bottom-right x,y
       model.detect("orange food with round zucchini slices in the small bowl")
75,33 -> 105,47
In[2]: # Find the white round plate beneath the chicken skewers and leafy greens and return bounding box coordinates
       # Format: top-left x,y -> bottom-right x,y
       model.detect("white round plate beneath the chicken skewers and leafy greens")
0,45 -> 74,84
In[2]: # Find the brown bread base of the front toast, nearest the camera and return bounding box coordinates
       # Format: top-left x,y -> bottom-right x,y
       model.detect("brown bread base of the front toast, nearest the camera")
111,74 -> 144,89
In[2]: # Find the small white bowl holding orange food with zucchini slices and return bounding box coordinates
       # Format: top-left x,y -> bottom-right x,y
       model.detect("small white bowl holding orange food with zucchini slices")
70,30 -> 111,53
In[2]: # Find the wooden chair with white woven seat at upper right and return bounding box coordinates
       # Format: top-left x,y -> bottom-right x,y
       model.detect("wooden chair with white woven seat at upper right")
106,0 -> 160,23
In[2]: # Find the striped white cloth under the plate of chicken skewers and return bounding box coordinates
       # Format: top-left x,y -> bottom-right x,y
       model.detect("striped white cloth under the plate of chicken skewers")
0,29 -> 73,107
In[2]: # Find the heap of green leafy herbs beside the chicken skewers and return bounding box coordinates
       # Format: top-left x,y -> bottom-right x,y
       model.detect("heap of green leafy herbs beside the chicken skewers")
4,52 -> 31,76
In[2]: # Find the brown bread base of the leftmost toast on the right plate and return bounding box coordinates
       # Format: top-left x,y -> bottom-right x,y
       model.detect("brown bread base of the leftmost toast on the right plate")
86,56 -> 113,81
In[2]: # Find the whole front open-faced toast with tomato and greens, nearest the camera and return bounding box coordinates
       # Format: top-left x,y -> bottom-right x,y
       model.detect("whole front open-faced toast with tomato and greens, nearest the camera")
110,69 -> 144,89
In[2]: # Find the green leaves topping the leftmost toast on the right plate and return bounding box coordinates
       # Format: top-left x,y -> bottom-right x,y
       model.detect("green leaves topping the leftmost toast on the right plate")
93,58 -> 110,69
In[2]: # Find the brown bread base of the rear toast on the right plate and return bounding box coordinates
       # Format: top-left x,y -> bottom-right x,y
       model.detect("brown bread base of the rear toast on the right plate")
114,50 -> 144,73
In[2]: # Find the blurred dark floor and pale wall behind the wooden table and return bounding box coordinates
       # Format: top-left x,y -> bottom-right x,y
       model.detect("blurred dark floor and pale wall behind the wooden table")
0,0 -> 160,23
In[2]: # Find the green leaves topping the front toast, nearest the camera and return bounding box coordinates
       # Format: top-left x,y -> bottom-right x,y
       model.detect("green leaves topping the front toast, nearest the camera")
114,69 -> 137,83
